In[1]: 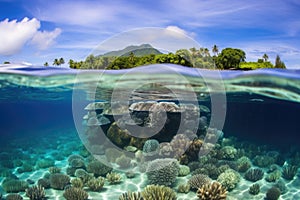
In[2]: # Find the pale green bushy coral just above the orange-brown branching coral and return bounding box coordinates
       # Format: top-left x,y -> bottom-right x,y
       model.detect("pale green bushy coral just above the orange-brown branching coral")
217,169 -> 240,191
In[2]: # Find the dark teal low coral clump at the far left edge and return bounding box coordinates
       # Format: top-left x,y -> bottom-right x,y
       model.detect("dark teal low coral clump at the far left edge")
2,178 -> 28,193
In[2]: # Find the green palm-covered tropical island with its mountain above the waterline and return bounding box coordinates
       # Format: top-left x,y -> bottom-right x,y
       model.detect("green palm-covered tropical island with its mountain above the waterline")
44,44 -> 286,70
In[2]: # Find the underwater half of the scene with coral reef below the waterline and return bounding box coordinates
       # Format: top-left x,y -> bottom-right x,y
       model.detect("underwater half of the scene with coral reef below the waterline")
0,64 -> 300,200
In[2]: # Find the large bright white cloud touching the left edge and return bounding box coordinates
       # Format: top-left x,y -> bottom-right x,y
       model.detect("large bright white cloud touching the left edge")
0,18 -> 40,55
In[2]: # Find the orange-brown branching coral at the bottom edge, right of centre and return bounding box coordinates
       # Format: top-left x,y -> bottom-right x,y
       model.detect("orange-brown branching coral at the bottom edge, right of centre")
197,182 -> 227,200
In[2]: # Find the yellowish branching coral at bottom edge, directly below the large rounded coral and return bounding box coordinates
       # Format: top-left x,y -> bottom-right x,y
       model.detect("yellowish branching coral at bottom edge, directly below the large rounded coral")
142,185 -> 177,200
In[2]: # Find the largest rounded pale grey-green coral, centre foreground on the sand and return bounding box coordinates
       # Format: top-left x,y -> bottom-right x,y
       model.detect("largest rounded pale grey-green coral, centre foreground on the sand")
146,158 -> 179,186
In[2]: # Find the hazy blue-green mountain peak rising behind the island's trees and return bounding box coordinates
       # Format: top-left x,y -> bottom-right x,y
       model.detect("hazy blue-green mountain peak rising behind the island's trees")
102,44 -> 162,57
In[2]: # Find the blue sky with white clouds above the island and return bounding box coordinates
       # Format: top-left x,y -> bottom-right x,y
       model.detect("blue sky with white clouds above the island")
0,0 -> 300,69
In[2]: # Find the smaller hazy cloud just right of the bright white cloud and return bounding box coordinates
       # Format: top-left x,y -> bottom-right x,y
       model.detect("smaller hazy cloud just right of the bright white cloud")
31,28 -> 61,50
